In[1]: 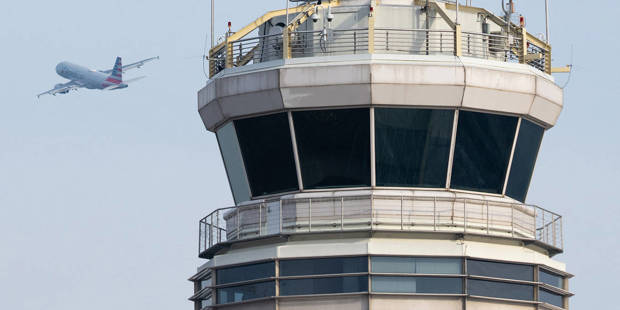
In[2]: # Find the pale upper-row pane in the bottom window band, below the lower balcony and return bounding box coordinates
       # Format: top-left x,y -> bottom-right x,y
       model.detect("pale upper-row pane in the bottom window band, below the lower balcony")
371,256 -> 462,274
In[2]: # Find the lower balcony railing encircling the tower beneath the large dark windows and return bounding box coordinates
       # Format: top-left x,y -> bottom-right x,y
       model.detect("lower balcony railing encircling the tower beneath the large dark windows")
199,195 -> 564,253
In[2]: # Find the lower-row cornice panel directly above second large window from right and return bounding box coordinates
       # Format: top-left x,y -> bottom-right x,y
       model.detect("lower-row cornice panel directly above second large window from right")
463,86 -> 534,114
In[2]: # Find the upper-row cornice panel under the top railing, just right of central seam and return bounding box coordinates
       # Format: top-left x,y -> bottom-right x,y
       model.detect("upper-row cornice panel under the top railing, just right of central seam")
371,63 -> 462,89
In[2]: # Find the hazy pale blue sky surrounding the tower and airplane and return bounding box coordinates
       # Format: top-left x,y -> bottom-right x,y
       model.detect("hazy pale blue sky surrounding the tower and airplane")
0,0 -> 620,310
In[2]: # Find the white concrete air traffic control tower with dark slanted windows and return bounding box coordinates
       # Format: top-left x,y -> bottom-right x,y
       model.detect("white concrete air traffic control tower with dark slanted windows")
190,0 -> 572,310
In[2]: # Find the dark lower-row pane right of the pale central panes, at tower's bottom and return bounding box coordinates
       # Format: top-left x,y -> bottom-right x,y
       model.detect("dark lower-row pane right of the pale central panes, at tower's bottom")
467,279 -> 534,300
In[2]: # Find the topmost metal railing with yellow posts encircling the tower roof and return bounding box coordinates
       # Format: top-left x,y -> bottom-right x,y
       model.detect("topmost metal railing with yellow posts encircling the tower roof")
209,28 -> 551,76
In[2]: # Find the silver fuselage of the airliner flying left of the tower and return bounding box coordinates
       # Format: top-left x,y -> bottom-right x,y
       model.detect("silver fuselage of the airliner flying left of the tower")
56,61 -> 127,89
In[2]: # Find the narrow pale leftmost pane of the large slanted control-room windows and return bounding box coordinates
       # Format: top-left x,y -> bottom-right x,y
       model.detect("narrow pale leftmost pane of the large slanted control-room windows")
216,122 -> 250,204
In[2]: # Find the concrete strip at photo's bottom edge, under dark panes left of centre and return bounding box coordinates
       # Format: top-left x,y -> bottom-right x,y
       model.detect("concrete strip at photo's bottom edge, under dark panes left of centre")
278,295 -> 368,310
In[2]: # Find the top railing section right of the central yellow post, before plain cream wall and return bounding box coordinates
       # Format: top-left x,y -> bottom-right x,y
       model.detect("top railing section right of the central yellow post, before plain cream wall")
375,28 -> 455,55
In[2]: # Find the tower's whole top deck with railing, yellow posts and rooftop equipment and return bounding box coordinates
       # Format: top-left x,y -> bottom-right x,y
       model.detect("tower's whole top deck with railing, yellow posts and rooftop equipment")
209,1 -> 552,78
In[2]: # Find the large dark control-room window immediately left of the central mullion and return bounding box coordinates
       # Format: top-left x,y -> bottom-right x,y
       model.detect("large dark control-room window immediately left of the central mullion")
293,109 -> 370,189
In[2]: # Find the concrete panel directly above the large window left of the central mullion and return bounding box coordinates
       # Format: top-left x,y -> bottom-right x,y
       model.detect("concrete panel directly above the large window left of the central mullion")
282,84 -> 370,109
